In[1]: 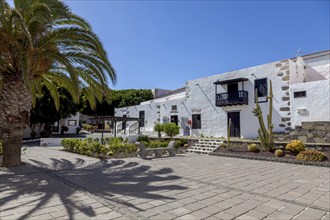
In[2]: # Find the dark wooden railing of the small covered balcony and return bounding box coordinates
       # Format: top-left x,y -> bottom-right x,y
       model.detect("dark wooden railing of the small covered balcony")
215,90 -> 249,106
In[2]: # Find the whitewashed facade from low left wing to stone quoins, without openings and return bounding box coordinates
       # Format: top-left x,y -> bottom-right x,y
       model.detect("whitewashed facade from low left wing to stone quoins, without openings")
116,63 -> 288,138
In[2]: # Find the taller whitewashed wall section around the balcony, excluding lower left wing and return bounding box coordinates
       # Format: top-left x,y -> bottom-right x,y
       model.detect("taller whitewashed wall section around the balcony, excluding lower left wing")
187,63 -> 288,138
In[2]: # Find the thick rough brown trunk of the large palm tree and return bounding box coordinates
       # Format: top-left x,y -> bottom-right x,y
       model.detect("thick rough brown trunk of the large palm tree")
0,74 -> 31,167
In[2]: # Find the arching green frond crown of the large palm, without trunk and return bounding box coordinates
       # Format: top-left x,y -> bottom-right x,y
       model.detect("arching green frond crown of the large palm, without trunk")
0,0 -> 116,111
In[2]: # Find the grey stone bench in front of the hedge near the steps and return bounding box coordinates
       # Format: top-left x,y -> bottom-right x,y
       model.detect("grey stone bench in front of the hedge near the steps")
135,141 -> 176,159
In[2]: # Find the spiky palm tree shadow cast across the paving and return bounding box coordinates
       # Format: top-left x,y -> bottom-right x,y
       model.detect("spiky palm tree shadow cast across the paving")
0,158 -> 186,219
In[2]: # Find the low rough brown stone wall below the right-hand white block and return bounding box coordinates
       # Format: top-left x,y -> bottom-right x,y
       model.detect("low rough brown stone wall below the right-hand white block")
274,121 -> 330,143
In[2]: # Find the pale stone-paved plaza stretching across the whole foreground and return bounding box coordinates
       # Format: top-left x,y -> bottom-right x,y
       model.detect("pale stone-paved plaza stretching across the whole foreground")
0,147 -> 330,220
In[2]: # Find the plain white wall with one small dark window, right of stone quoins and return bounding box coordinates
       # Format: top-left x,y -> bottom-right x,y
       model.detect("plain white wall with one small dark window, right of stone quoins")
290,80 -> 330,127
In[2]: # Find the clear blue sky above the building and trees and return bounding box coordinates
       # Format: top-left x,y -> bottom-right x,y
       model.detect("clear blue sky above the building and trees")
10,0 -> 330,89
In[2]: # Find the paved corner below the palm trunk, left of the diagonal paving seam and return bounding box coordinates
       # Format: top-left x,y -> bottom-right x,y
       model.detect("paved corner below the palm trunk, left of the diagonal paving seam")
0,167 -> 123,219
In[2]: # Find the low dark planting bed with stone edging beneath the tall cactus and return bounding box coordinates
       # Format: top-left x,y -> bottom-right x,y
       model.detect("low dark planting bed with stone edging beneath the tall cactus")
210,147 -> 330,167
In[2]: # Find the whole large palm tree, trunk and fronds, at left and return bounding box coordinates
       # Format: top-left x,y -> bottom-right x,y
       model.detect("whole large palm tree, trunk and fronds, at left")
0,0 -> 116,166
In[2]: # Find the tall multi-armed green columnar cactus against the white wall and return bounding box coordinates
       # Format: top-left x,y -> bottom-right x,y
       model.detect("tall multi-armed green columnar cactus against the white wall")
252,80 -> 274,151
